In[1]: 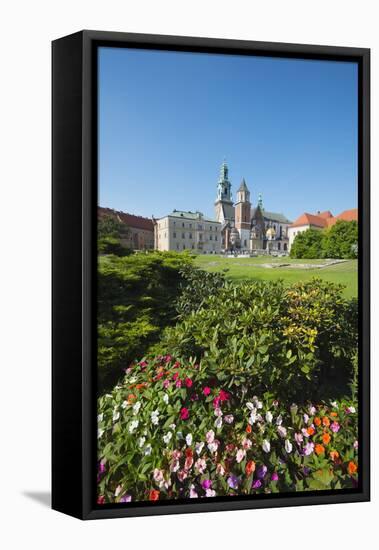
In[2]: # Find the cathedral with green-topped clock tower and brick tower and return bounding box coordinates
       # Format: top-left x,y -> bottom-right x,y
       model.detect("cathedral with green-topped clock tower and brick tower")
215,161 -> 292,254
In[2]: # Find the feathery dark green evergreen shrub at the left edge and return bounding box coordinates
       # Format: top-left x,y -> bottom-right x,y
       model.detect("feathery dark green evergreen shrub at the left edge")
98,252 -> 192,393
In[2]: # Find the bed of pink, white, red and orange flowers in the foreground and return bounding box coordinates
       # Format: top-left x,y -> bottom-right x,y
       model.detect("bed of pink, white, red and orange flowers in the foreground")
98,355 -> 358,504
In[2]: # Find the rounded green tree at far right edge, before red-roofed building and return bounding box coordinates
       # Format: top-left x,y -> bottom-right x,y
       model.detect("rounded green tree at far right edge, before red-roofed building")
323,220 -> 358,259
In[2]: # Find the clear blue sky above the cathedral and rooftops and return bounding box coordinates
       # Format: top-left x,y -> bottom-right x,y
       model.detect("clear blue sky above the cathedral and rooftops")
99,48 -> 358,220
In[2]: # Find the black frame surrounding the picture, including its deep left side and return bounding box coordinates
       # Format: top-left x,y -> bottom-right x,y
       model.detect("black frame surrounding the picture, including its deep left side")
52,30 -> 370,519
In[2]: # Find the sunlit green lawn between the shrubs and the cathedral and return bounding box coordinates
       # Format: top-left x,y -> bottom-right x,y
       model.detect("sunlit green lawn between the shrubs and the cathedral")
195,255 -> 358,297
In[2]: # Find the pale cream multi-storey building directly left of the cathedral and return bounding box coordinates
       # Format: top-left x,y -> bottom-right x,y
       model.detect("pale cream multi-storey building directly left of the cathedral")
153,210 -> 221,254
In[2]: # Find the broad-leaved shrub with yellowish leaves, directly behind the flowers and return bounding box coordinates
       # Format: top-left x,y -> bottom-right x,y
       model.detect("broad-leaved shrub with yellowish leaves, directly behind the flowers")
154,280 -> 357,399
